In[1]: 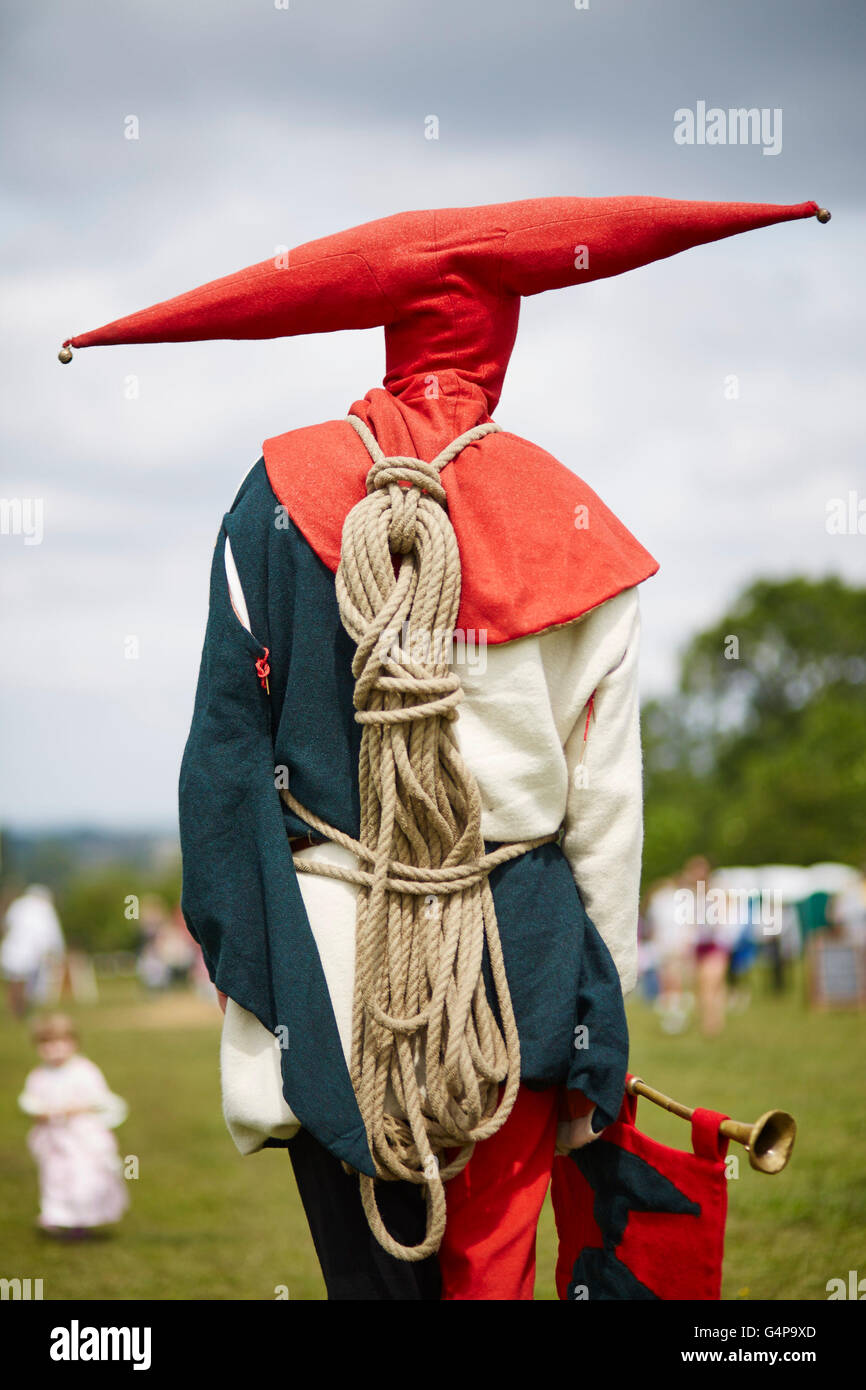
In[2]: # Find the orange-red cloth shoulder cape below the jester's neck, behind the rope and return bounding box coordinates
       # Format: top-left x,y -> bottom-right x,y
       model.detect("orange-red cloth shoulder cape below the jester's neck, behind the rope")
263,420 -> 659,644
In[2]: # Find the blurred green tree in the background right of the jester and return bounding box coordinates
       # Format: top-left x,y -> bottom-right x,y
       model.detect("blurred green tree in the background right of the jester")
644,577 -> 866,881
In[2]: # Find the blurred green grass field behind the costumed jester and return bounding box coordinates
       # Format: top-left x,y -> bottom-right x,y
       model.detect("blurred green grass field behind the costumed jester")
0,980 -> 866,1300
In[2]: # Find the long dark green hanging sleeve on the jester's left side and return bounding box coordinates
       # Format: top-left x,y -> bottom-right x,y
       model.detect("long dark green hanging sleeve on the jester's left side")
179,464 -> 373,1175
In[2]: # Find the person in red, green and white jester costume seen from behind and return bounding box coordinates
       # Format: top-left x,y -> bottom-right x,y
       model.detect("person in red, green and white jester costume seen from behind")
61,197 -> 824,1300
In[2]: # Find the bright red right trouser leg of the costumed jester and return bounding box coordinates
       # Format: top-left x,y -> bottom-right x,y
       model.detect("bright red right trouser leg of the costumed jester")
439,1086 -> 559,1301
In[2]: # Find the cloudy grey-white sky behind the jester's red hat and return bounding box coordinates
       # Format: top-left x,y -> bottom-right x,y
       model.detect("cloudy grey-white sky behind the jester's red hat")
0,0 -> 866,828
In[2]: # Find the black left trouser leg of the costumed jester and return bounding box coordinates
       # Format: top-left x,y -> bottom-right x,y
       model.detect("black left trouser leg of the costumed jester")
288,1129 -> 442,1301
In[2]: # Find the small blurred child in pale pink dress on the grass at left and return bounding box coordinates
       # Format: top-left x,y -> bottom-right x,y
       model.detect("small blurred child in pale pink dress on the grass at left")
18,1013 -> 129,1236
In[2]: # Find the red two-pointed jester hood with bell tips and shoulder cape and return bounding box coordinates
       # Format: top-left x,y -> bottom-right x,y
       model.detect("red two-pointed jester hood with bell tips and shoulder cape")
60,197 -> 830,642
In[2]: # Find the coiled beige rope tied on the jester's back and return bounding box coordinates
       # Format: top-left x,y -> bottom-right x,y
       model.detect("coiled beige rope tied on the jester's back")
281,416 -> 556,1261
